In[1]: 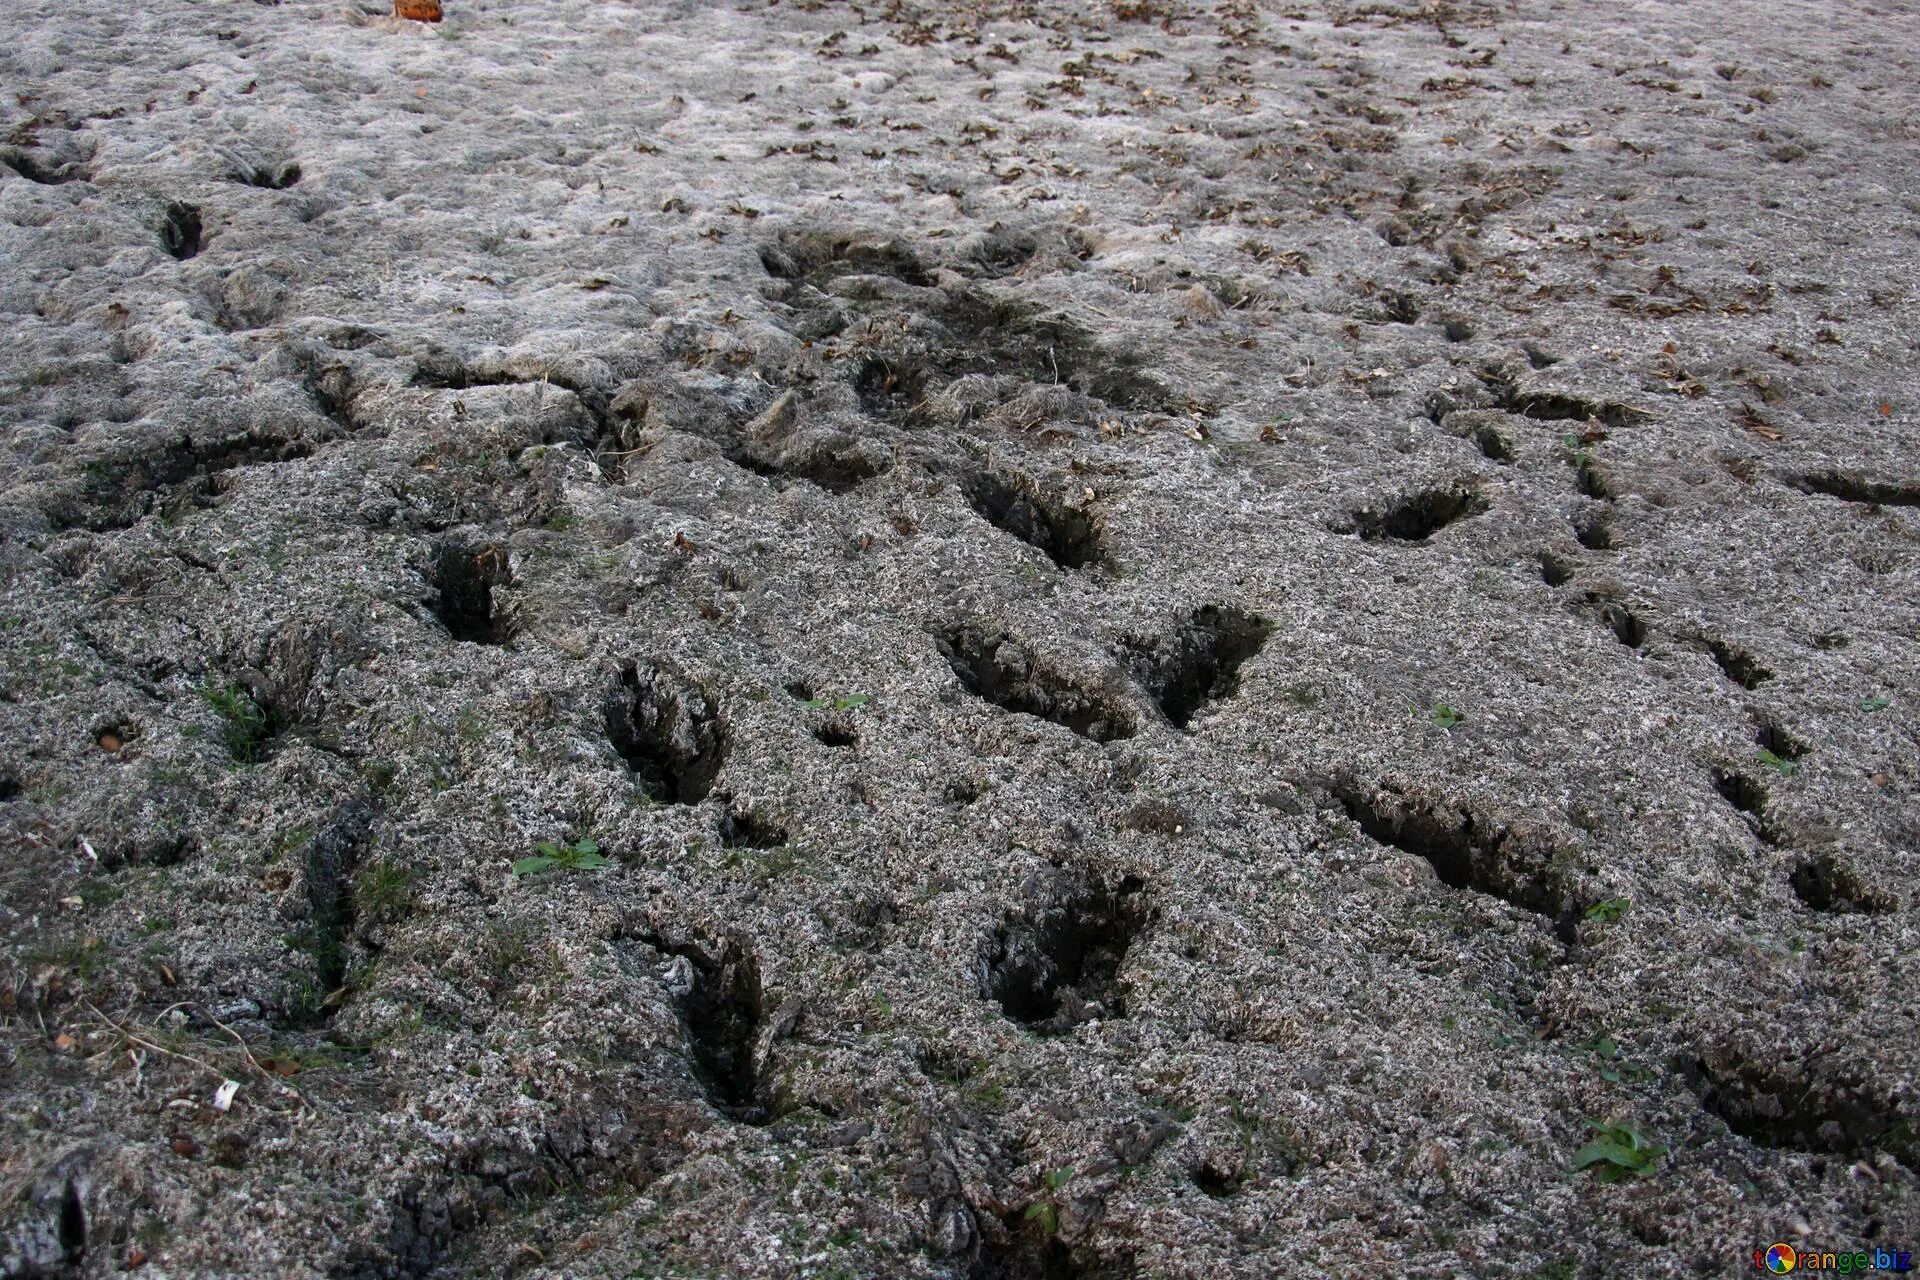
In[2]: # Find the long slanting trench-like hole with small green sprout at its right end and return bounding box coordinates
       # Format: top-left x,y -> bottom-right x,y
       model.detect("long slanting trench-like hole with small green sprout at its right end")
1334,781 -> 1578,942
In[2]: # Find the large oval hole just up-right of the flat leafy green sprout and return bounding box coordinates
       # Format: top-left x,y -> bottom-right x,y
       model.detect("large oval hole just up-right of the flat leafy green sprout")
605,664 -> 726,804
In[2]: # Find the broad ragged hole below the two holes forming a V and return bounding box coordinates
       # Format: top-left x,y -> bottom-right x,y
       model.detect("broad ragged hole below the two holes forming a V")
983,877 -> 1148,1034
